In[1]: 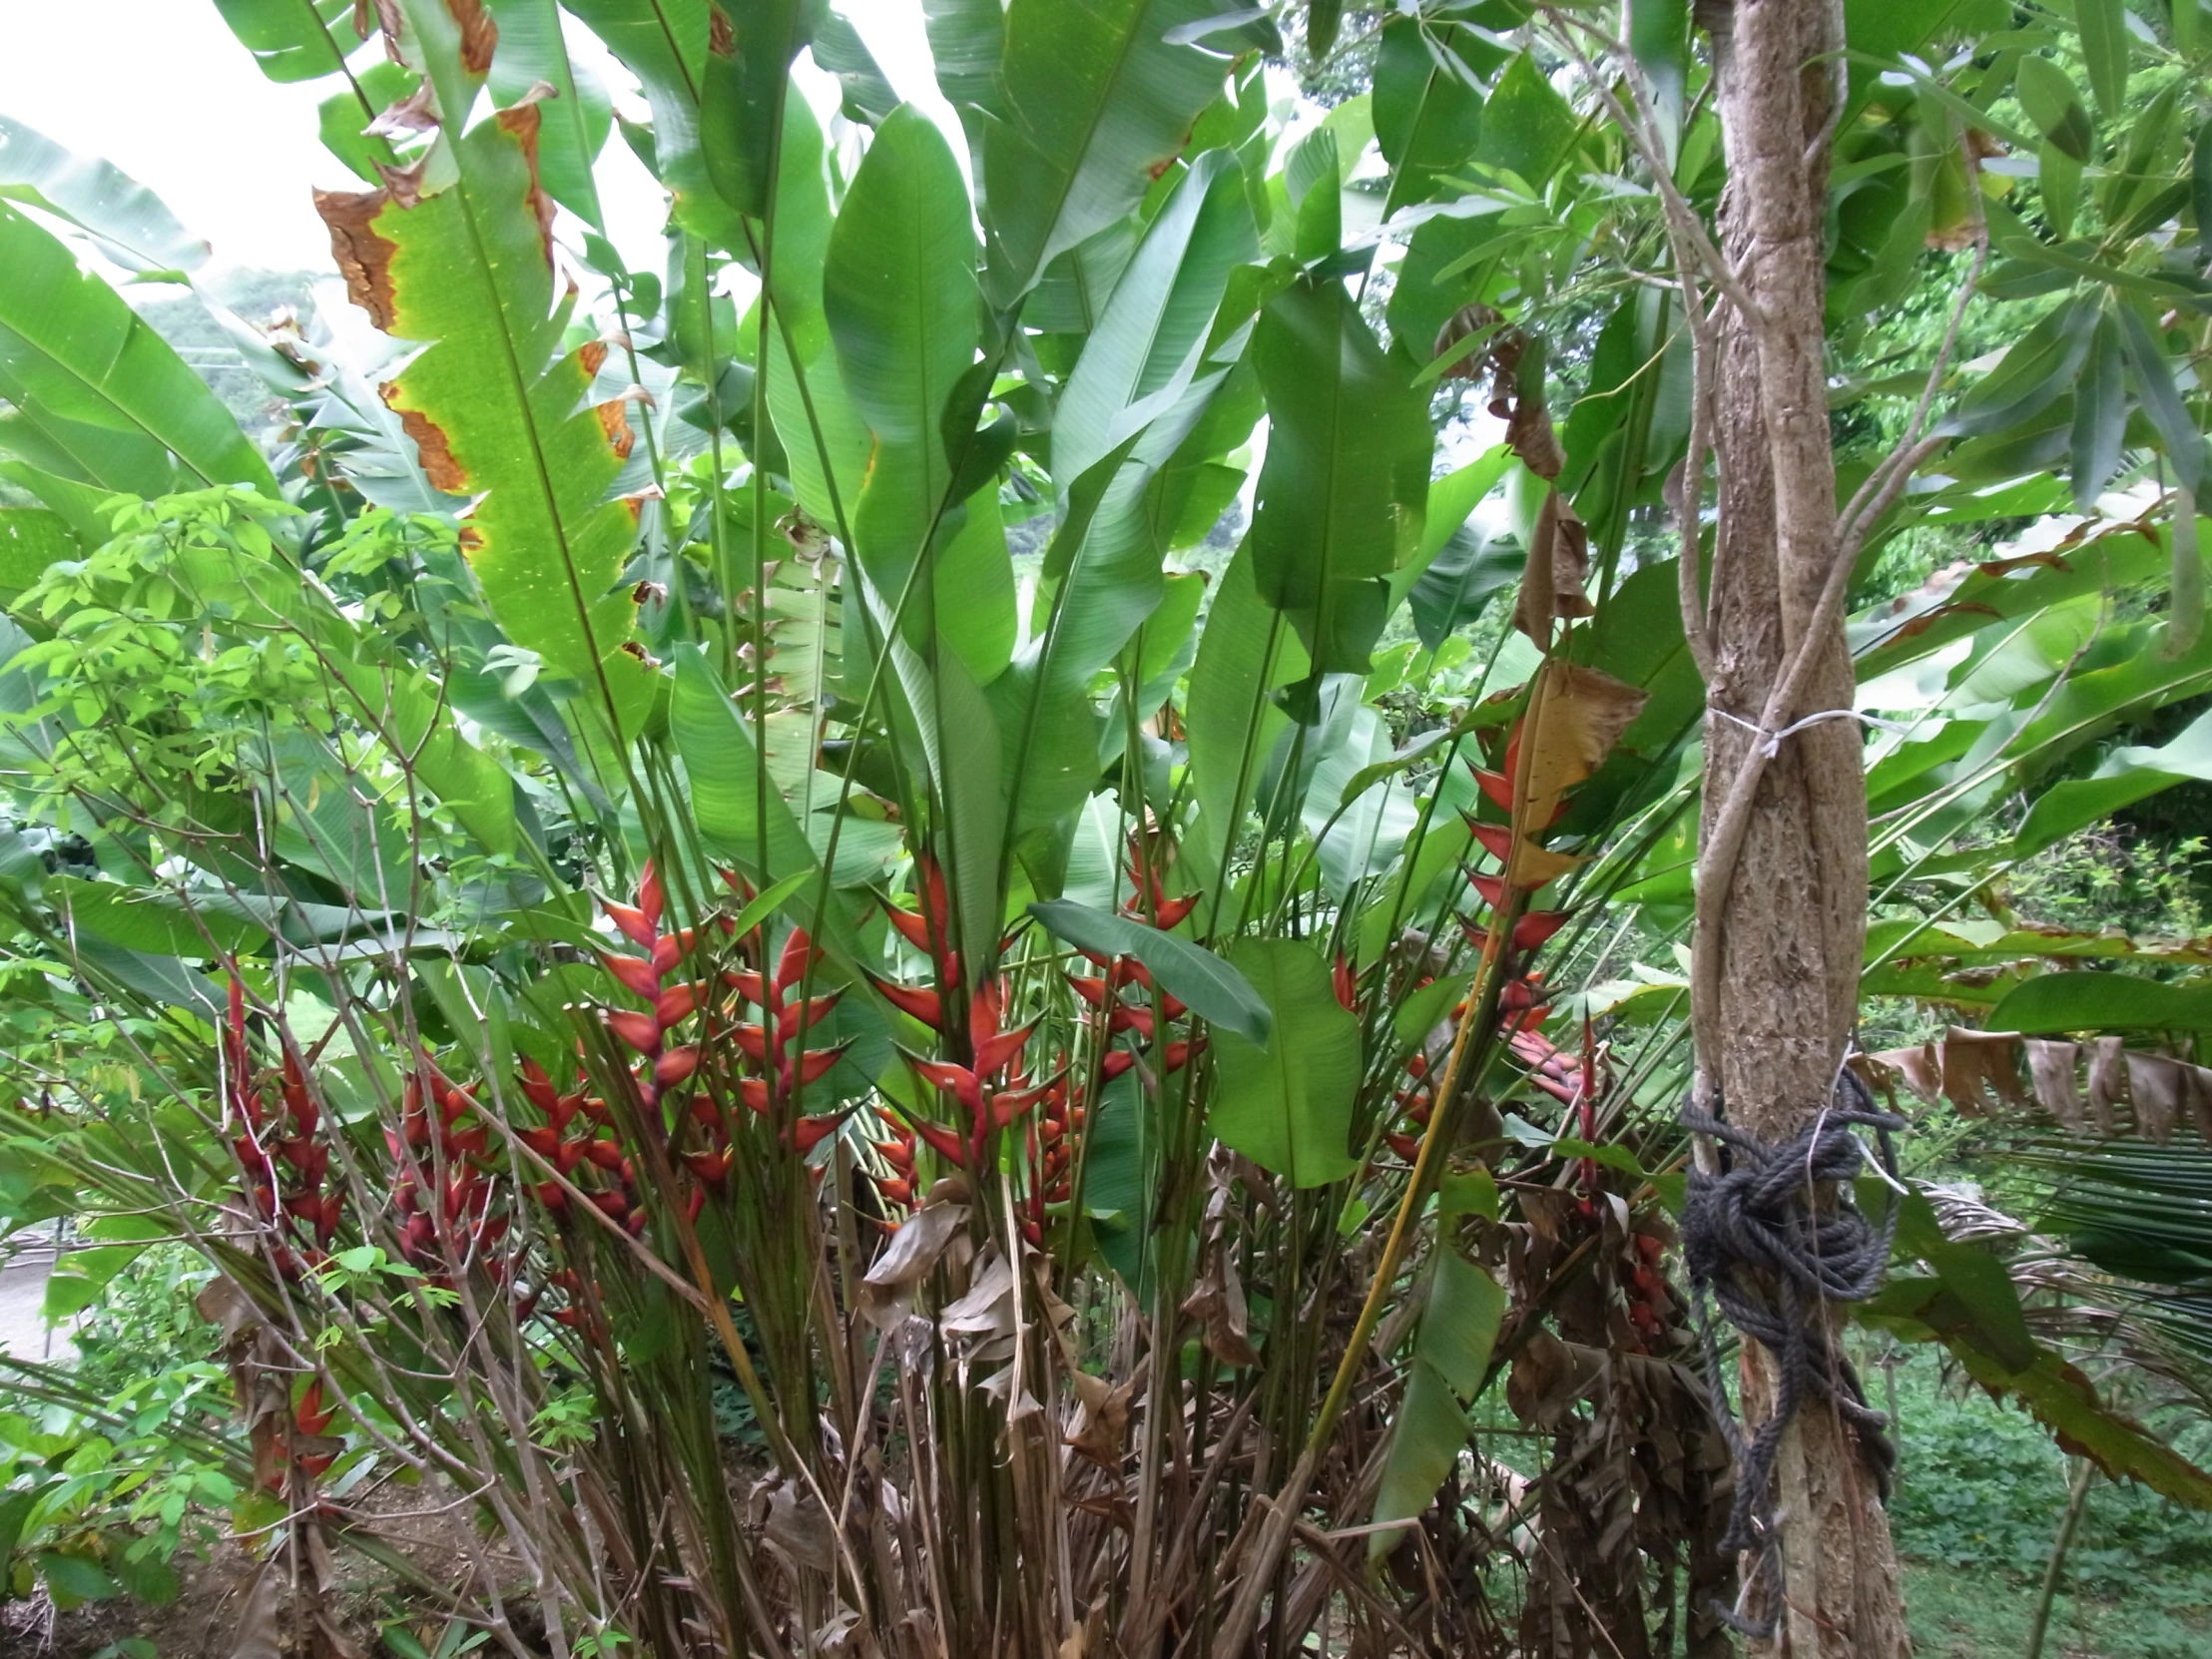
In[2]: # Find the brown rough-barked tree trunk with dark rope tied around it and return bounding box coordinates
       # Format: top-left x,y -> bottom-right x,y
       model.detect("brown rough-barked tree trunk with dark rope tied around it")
1697,0 -> 1912,1659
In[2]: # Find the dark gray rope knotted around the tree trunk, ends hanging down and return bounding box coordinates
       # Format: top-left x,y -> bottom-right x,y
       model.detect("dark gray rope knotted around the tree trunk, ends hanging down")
1681,1071 -> 1905,1639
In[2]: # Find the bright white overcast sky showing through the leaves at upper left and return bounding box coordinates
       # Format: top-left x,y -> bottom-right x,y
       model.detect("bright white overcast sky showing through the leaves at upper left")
0,0 -> 946,282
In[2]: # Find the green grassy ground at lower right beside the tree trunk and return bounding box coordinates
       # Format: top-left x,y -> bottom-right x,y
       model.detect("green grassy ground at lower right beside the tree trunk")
1876,1352 -> 2212,1659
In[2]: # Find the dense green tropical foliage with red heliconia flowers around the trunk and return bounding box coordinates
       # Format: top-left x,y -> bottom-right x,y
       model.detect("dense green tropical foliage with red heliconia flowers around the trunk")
0,0 -> 2212,1659
